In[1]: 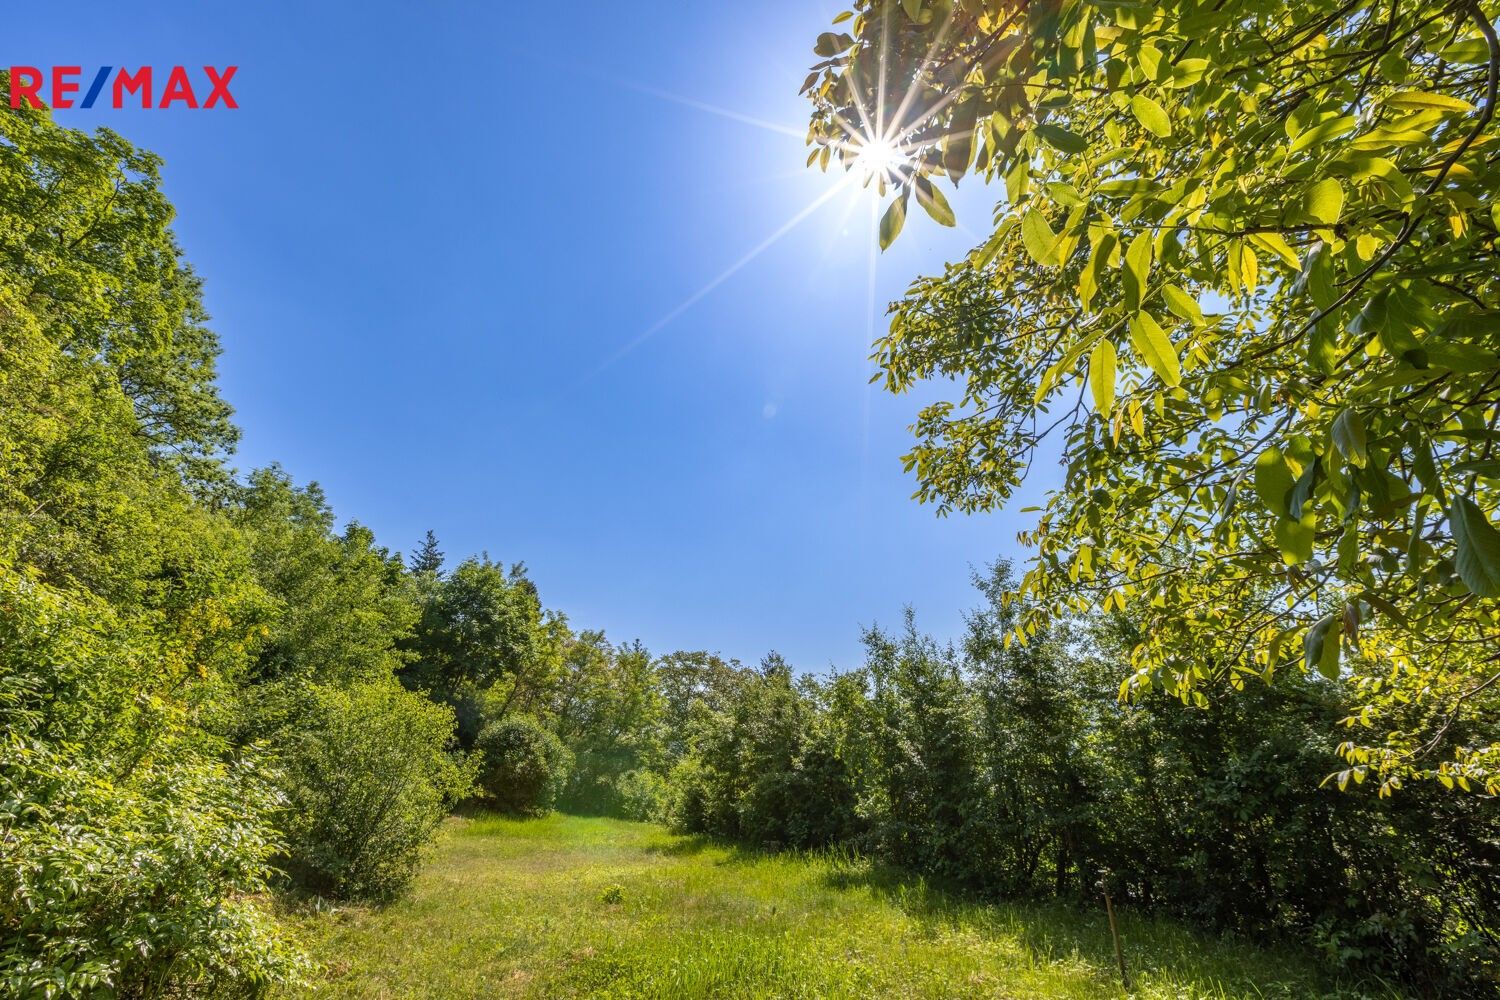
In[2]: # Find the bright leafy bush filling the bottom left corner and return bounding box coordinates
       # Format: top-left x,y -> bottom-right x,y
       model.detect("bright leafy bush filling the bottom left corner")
0,565 -> 300,997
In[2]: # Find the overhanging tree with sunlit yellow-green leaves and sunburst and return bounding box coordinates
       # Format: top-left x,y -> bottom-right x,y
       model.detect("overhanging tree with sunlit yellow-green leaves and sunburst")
804,0 -> 1500,793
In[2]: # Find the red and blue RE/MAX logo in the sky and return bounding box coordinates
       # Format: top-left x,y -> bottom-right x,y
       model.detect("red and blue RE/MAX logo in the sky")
11,66 -> 240,108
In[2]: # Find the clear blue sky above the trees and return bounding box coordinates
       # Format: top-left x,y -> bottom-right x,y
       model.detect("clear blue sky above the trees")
20,0 -> 1056,670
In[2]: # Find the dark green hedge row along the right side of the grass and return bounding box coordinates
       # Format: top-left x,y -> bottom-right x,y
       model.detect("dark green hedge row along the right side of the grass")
668,562 -> 1500,994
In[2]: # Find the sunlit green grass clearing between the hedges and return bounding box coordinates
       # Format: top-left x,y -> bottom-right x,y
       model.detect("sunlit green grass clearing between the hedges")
276,816 -> 1398,999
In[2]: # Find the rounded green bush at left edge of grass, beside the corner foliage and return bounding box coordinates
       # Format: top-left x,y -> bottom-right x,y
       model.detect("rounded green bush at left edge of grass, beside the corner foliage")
287,679 -> 474,900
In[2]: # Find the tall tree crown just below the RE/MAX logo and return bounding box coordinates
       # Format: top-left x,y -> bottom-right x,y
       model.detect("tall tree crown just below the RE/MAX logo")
0,73 -> 237,481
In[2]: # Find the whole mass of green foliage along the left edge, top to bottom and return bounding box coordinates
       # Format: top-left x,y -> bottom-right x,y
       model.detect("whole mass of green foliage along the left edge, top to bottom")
0,73 -> 310,996
